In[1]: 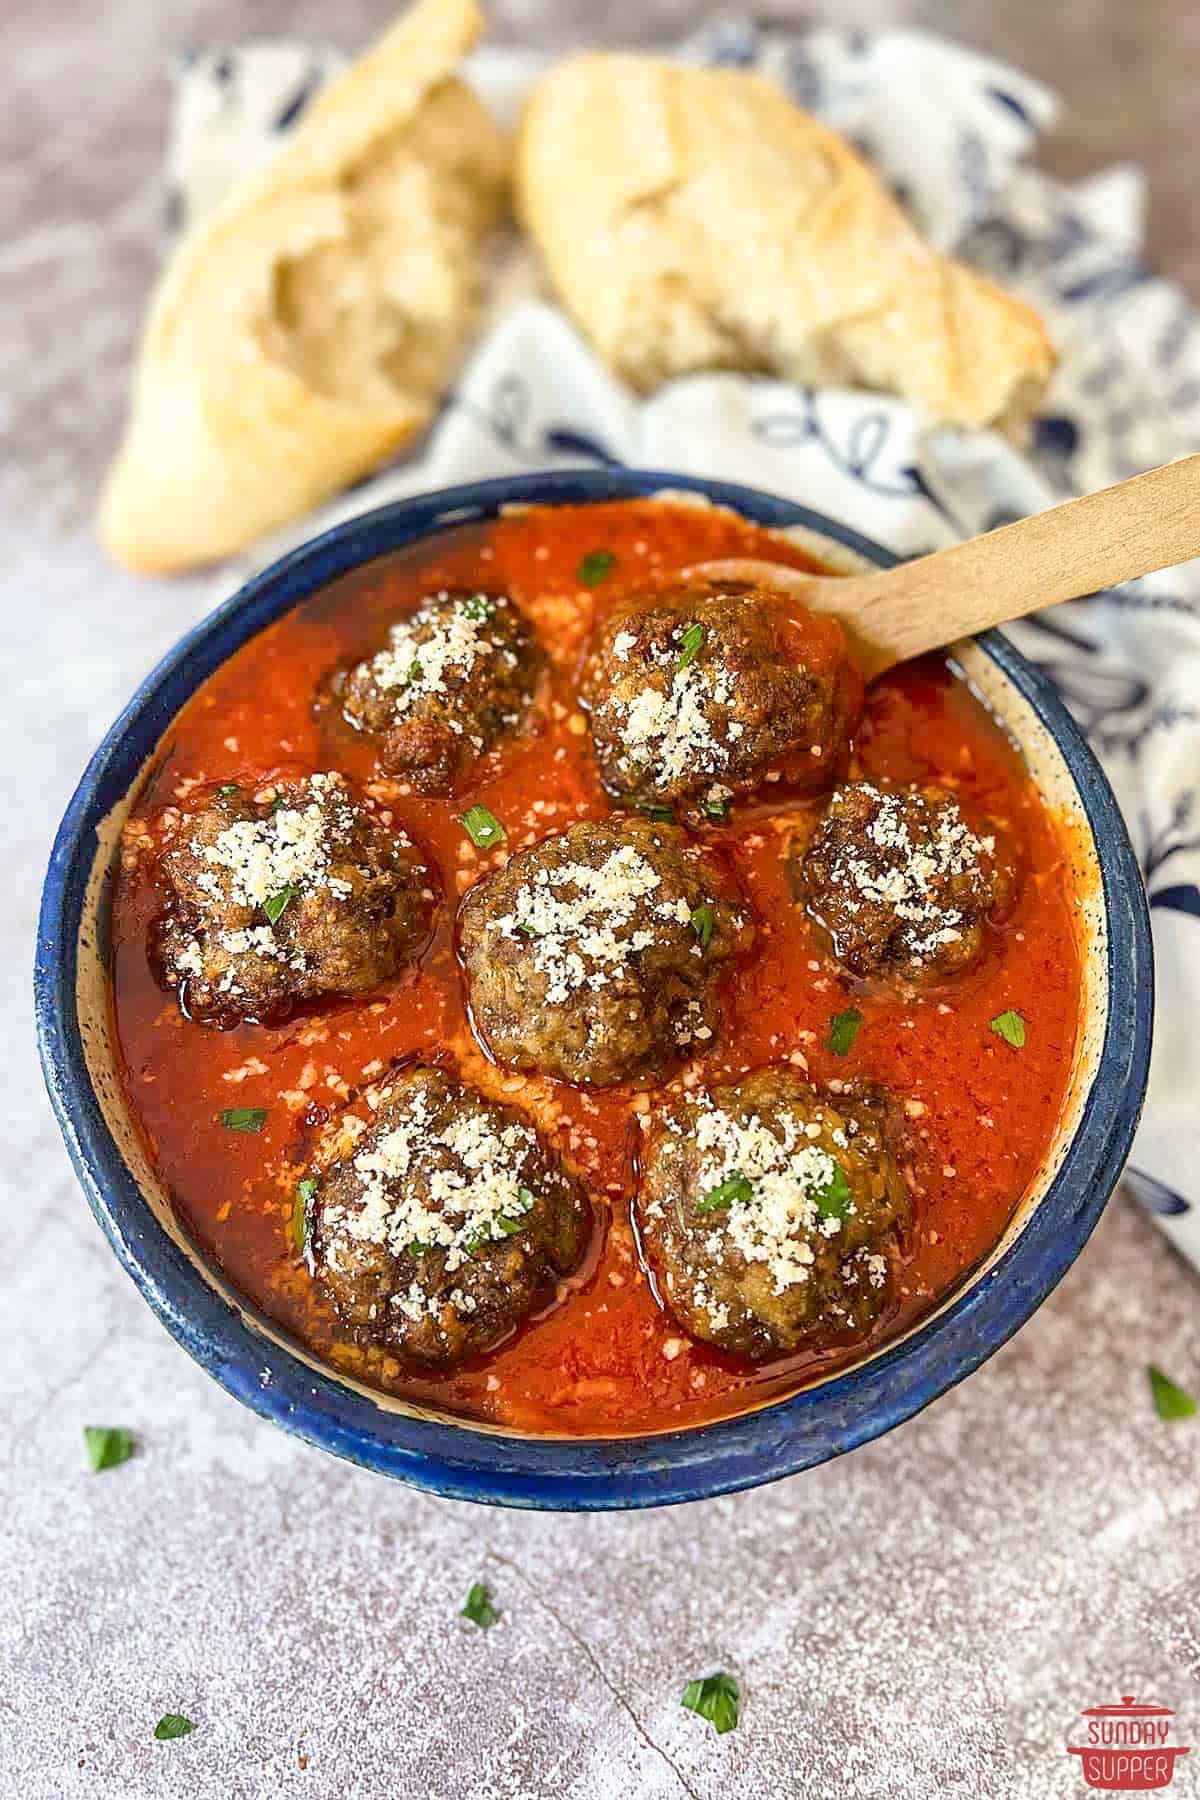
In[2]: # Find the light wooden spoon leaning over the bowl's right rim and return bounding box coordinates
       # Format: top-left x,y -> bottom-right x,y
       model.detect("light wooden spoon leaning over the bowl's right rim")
691,455 -> 1200,680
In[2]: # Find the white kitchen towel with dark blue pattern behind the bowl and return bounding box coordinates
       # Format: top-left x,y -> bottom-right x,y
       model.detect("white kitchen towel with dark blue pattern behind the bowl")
161,20 -> 1200,1265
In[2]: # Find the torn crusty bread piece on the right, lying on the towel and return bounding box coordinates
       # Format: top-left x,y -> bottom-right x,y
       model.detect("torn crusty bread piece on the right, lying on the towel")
516,54 -> 1052,425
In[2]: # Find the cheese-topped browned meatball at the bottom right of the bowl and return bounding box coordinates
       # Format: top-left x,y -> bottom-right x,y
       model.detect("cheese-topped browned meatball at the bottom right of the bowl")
637,1069 -> 910,1357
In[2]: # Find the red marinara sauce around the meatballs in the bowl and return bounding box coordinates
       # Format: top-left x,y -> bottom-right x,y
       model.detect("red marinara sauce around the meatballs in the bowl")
113,500 -> 1081,1435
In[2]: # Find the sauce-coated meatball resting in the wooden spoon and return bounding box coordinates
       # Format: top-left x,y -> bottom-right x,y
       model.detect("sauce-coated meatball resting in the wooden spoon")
581,583 -> 853,819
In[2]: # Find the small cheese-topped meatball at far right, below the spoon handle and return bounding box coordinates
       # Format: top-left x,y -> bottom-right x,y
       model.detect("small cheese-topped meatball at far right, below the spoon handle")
792,781 -> 1016,981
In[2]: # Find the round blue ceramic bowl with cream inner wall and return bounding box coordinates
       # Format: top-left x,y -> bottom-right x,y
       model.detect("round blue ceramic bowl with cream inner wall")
36,470 -> 1153,1508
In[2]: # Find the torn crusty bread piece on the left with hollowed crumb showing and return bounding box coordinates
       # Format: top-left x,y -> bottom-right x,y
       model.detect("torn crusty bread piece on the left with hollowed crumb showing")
99,0 -> 507,571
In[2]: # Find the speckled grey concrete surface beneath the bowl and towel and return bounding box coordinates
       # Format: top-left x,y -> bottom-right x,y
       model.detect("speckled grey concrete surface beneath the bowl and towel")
0,0 -> 1200,1800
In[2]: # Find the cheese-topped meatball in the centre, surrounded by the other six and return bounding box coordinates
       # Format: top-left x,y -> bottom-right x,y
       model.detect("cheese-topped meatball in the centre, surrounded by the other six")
459,817 -> 754,1087
